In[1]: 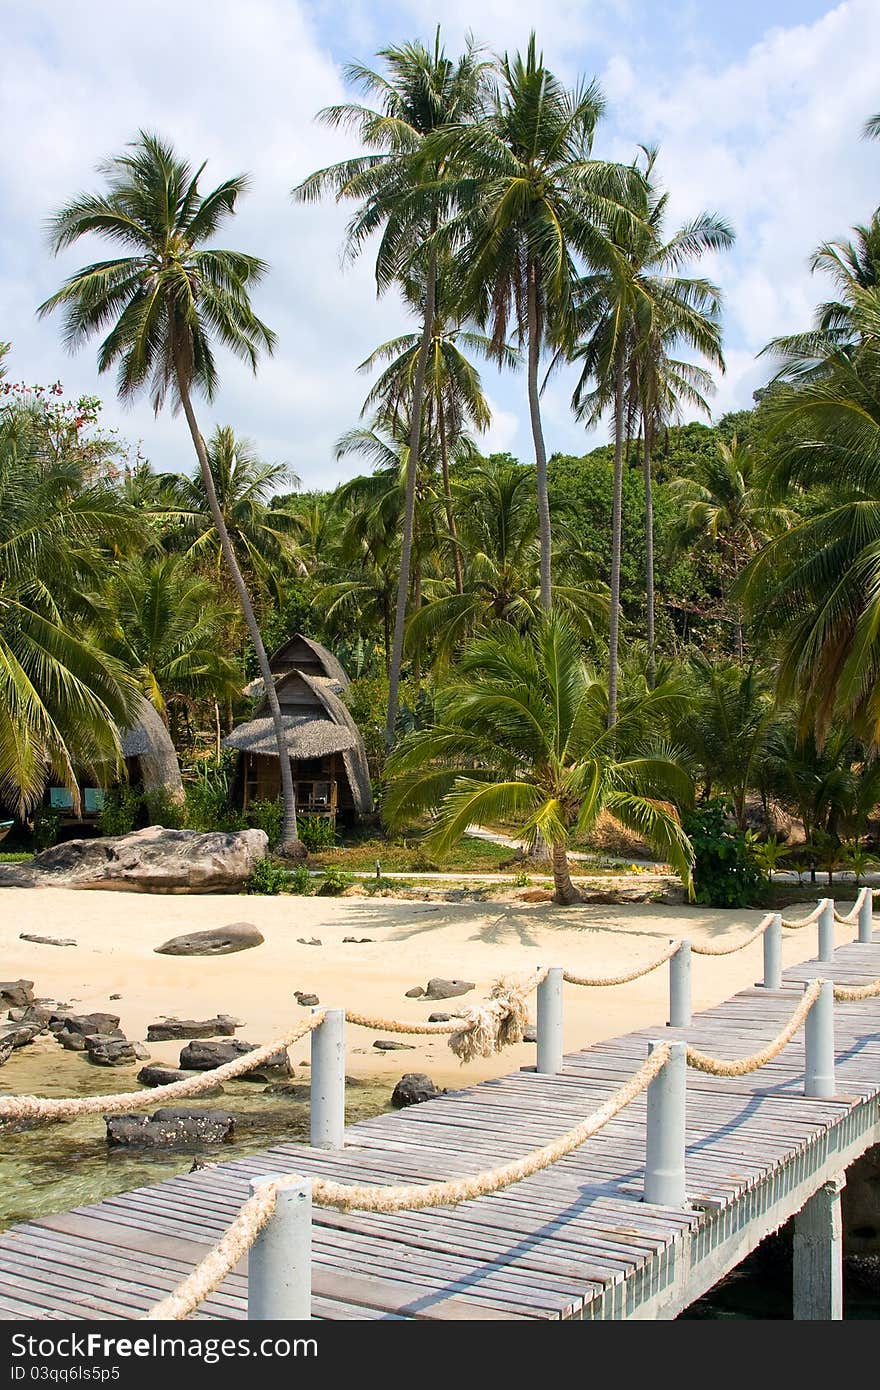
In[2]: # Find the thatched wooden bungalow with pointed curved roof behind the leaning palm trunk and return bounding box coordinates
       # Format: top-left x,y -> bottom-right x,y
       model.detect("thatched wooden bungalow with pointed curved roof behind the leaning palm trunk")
224,632 -> 373,821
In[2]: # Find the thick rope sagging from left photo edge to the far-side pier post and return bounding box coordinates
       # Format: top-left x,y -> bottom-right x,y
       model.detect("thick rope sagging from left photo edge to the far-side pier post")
0,1013 -> 324,1120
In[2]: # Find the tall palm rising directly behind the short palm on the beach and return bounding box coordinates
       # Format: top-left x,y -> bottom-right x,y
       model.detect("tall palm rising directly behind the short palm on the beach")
431,33 -> 641,609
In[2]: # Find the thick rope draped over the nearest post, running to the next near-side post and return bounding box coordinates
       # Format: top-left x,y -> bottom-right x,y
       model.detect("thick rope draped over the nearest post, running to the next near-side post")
145,1044 -> 670,1322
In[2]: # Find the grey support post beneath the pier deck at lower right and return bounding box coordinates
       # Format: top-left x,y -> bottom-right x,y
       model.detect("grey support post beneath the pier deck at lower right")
792,1175 -> 845,1322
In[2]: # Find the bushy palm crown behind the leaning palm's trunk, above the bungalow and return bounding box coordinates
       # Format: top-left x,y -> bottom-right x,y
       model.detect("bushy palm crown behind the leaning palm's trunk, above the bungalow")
161,425 -> 299,602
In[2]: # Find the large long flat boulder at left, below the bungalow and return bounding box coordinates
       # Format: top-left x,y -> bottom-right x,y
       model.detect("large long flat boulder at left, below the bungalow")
3,826 -> 268,895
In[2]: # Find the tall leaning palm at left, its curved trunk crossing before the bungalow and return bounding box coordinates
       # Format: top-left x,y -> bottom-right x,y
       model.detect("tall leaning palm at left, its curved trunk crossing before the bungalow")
39,141 -> 302,853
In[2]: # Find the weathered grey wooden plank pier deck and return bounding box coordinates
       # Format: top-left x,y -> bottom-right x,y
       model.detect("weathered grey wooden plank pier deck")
0,940 -> 880,1319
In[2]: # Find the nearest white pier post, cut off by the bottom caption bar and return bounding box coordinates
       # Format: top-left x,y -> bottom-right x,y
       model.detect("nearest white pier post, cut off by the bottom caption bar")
247,1173 -> 311,1322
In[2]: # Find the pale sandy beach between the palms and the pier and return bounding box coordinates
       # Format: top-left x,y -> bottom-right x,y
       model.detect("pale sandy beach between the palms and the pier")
0,888 -> 852,1091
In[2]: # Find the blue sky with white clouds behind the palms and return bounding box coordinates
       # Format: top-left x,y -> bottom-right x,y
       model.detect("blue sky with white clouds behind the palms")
0,0 -> 880,488
